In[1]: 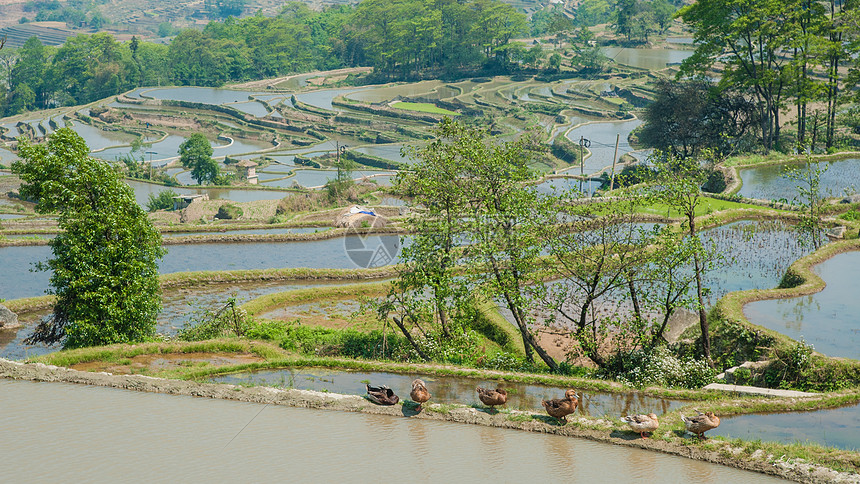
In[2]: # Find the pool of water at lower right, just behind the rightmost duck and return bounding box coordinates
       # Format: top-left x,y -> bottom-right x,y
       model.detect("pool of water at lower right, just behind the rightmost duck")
708,405 -> 860,450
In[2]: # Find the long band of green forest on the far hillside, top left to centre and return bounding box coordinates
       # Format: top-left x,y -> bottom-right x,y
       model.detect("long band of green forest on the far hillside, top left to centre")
0,0 -> 596,116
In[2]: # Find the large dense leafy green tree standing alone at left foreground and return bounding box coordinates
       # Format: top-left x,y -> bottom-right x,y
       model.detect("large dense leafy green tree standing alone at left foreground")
12,128 -> 164,348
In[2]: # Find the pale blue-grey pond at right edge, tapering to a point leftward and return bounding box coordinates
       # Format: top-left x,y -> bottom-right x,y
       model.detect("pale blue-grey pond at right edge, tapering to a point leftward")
744,252 -> 860,359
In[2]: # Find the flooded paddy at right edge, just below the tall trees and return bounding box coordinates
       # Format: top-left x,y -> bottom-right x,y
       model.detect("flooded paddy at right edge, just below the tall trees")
738,158 -> 860,202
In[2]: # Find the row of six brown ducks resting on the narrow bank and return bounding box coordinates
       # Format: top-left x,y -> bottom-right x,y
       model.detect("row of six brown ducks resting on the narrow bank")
366,379 -> 720,439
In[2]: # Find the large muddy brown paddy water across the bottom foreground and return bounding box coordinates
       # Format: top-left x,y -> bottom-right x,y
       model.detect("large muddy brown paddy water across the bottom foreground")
0,380 -> 784,483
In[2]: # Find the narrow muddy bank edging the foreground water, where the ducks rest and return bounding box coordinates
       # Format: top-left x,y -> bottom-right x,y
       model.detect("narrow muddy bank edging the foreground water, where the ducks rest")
0,359 -> 860,483
